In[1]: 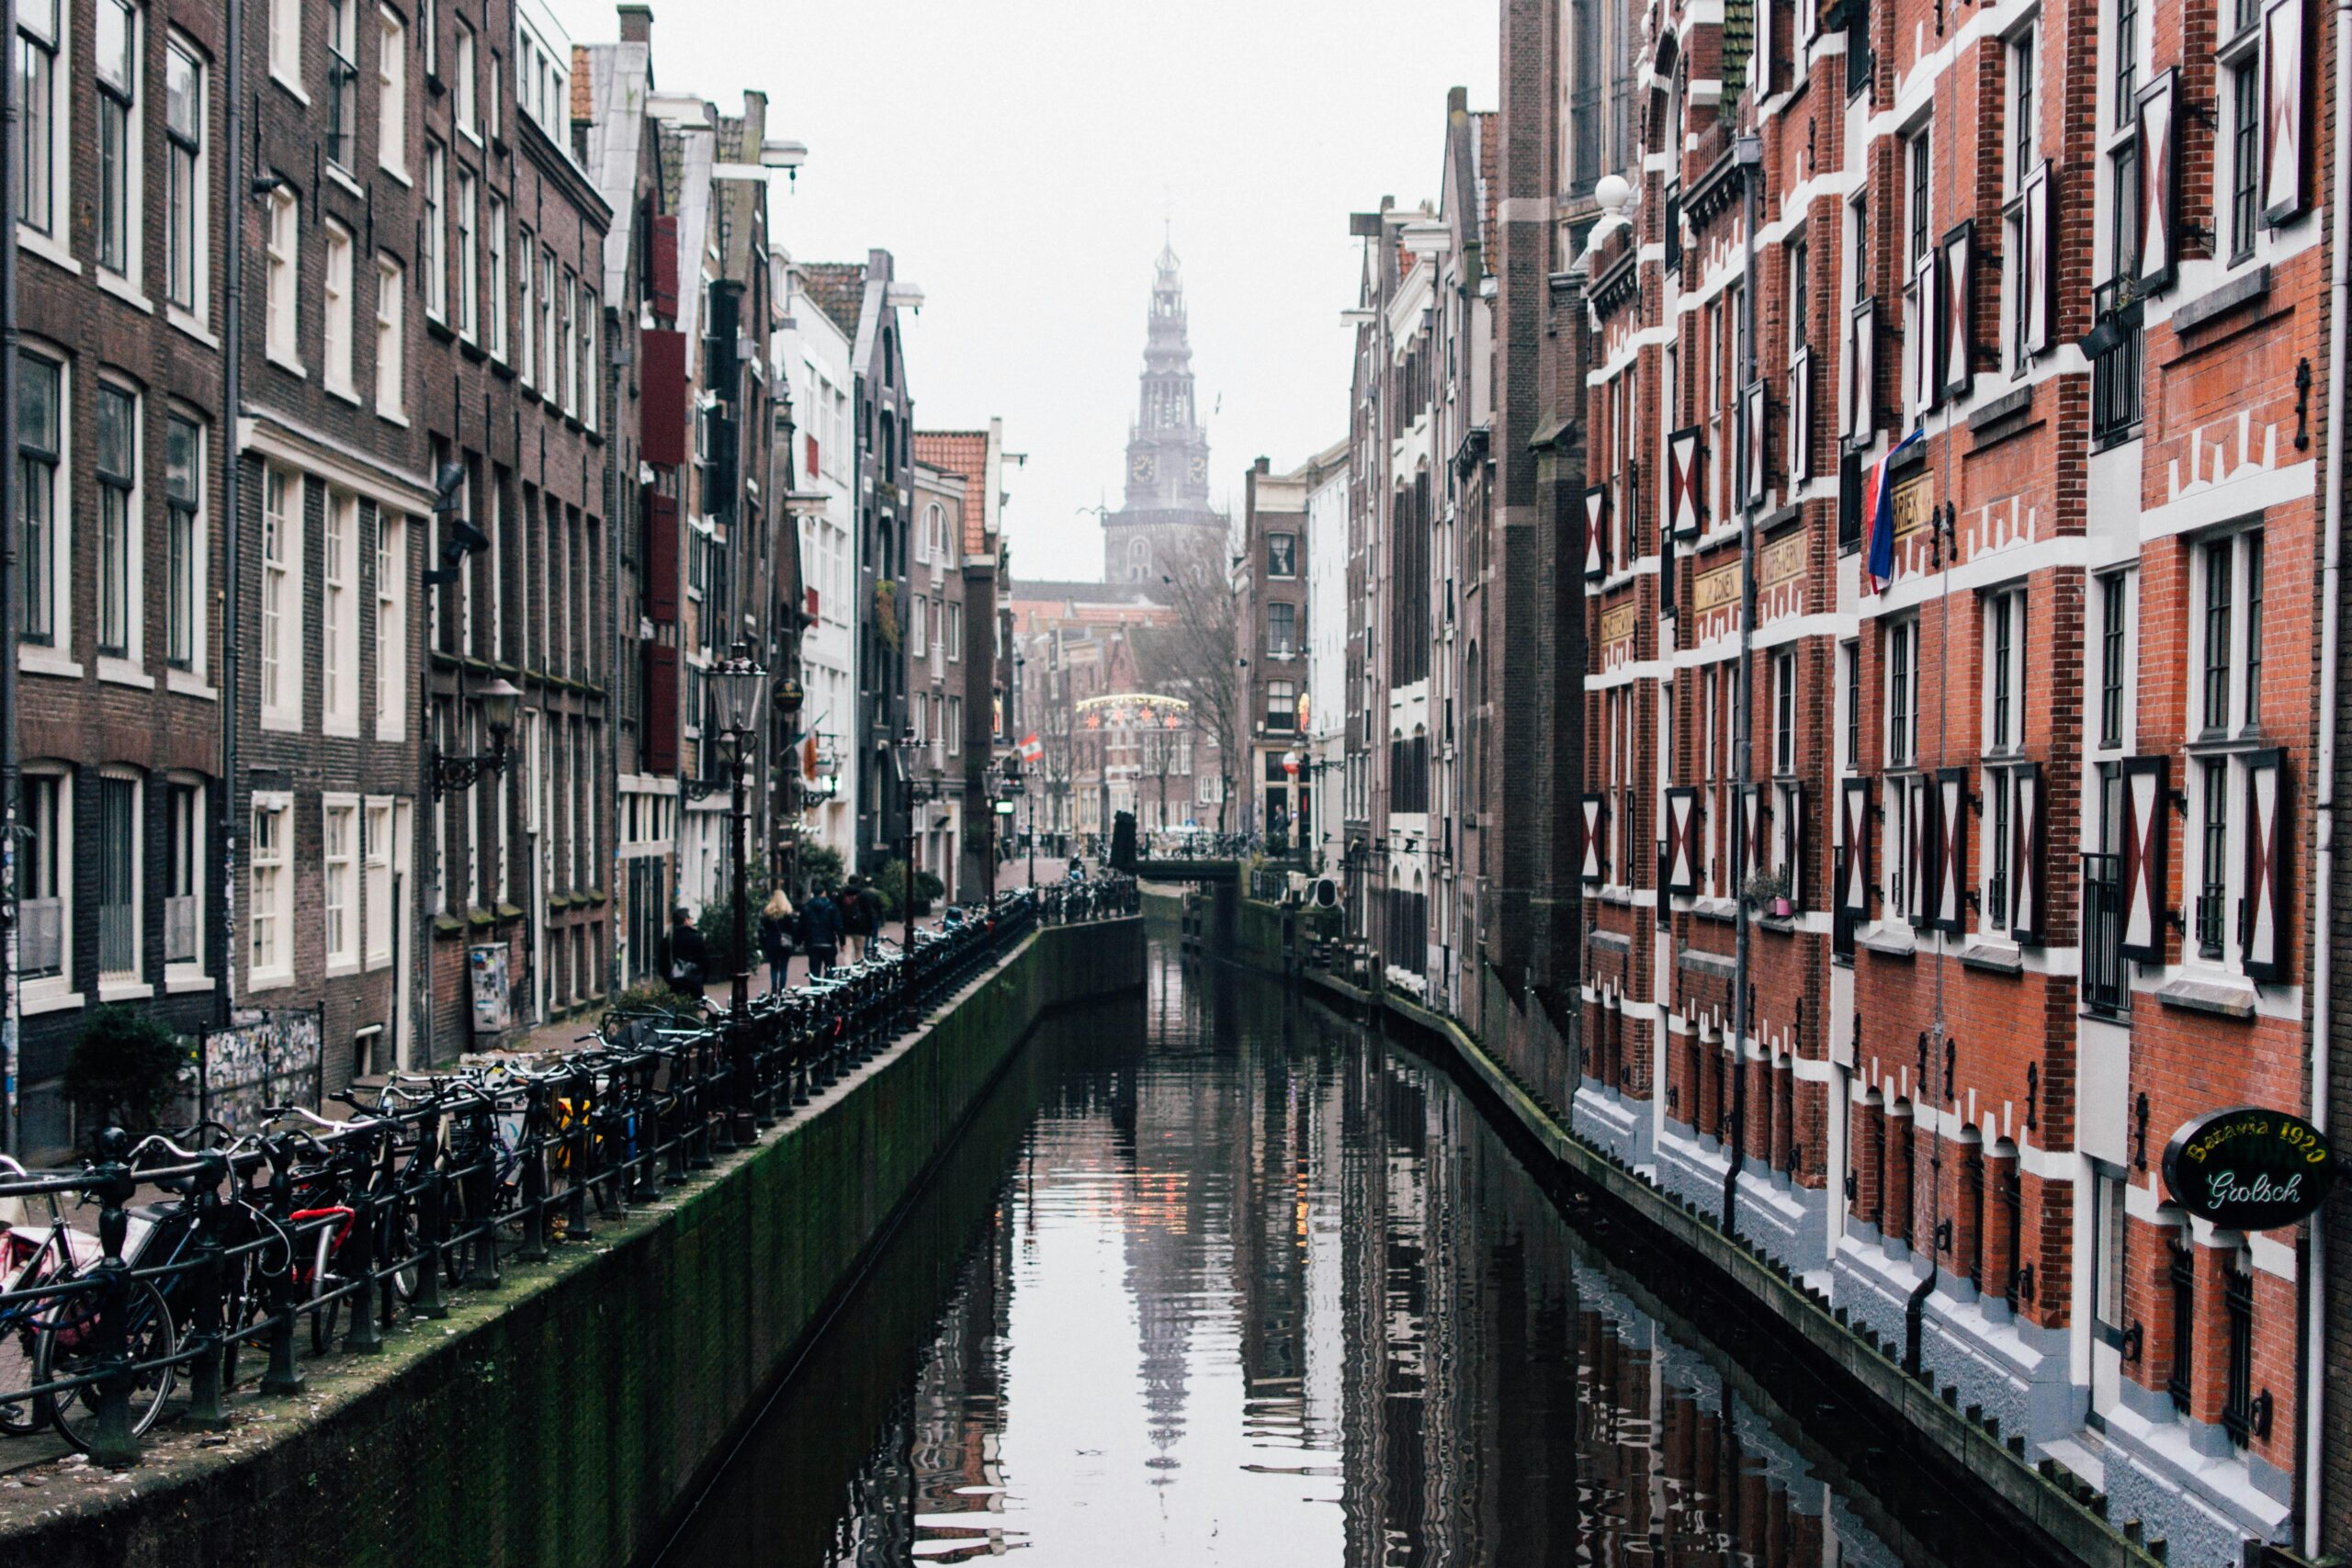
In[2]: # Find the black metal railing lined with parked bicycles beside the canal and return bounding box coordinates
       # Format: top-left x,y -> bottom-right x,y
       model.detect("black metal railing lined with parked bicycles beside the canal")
0,877 -> 1136,1464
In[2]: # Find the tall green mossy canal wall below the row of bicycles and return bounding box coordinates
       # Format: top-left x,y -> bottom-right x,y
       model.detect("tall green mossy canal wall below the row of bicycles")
0,917 -> 1146,1568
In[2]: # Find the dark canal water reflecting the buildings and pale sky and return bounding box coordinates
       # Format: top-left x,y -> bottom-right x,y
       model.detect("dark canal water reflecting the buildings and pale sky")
663,942 -> 1984,1568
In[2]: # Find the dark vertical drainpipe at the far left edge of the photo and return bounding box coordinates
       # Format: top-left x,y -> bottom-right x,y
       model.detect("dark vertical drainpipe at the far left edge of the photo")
0,0 -> 18,1155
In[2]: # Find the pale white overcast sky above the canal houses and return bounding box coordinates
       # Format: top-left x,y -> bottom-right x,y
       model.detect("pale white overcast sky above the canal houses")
553,0 -> 1500,579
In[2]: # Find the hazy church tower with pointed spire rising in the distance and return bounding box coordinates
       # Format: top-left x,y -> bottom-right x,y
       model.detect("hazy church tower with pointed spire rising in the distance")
1103,249 -> 1226,583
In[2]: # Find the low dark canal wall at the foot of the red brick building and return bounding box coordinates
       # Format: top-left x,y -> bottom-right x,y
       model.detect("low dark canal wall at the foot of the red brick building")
1270,947 -> 2162,1568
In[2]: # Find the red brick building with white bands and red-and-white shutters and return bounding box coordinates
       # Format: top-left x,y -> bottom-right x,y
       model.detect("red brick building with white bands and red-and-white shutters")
1571,0 -> 2326,1563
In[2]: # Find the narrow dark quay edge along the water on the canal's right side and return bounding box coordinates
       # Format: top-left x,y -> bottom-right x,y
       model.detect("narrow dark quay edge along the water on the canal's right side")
1204,891 -> 2173,1568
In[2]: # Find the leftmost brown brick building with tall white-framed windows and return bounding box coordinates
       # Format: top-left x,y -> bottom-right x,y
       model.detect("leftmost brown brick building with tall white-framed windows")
5,0 -> 233,1159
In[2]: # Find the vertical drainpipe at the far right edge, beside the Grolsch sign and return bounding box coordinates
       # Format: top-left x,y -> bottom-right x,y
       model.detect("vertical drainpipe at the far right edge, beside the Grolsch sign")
2296,0 -> 2352,1556
